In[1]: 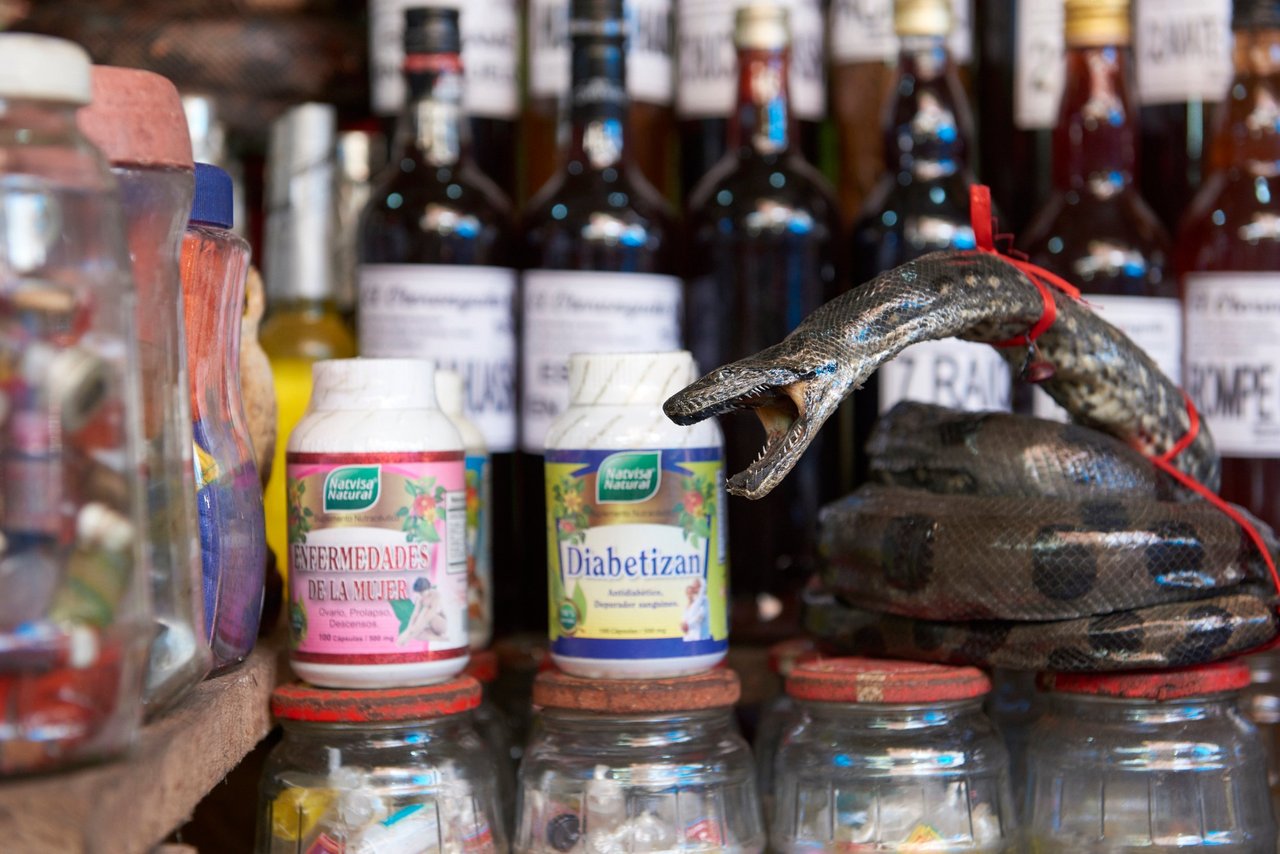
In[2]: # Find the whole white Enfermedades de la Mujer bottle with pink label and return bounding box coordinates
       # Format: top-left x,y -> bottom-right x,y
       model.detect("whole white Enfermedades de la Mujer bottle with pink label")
285,359 -> 468,688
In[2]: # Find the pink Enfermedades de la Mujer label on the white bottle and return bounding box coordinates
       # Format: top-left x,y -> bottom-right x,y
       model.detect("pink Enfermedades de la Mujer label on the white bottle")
288,452 -> 467,665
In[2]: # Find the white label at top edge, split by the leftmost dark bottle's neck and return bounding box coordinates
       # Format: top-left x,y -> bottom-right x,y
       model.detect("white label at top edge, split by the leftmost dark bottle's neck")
369,0 -> 520,119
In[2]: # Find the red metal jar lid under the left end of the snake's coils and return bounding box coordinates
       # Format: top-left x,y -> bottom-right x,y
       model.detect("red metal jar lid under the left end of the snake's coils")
787,658 -> 991,703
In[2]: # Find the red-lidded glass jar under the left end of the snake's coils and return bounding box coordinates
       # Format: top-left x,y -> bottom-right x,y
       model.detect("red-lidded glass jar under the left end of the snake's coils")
769,658 -> 1018,853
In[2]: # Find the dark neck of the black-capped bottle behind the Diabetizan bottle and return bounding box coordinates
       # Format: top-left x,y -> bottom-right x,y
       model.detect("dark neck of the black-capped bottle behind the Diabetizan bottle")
568,33 -> 628,173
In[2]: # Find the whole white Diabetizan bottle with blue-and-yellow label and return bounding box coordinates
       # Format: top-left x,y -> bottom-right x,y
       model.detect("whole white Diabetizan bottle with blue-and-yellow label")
547,351 -> 728,679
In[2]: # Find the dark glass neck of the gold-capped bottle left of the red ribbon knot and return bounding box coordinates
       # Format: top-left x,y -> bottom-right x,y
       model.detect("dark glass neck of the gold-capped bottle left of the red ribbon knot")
884,36 -> 970,181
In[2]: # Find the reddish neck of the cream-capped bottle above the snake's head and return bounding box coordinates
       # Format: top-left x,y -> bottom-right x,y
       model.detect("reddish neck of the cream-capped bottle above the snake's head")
728,49 -> 795,155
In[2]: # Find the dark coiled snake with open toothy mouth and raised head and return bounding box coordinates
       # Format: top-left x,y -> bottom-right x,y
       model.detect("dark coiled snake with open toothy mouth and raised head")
666,252 -> 1280,670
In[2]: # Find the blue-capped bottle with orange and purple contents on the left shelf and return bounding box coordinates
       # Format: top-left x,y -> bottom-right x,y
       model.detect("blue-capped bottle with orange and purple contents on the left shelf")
182,163 -> 266,671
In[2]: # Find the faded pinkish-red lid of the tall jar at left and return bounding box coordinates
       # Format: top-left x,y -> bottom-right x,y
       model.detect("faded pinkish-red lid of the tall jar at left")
76,65 -> 195,170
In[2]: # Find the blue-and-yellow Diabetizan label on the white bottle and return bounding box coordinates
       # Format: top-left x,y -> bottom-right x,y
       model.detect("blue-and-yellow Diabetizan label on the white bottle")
547,448 -> 728,658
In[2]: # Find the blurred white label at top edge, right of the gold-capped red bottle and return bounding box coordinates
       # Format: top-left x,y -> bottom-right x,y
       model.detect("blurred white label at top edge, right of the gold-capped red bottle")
1133,0 -> 1231,105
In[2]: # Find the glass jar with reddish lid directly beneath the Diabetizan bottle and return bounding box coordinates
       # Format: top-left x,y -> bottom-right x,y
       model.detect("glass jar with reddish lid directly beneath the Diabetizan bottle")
515,670 -> 764,854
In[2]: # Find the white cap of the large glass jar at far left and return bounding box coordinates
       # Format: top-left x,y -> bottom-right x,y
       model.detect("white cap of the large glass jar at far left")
0,33 -> 93,106
